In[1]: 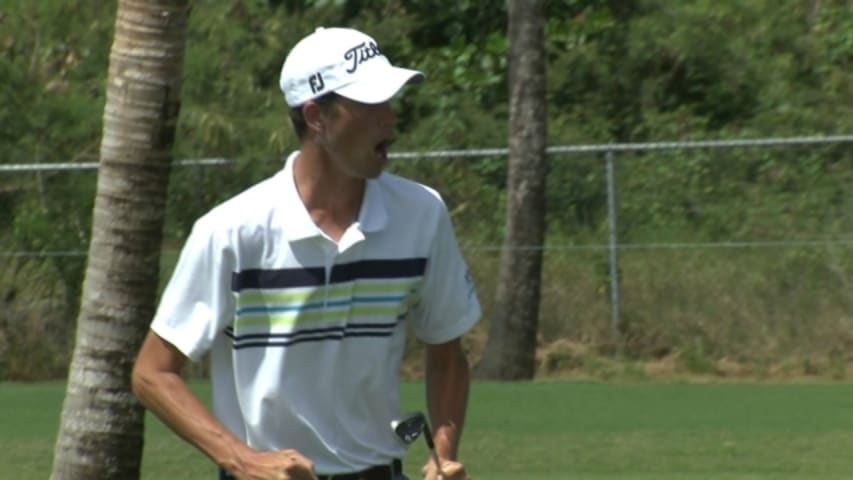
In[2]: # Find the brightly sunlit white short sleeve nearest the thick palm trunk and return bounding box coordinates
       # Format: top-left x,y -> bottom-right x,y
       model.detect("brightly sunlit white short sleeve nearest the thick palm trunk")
151,218 -> 234,360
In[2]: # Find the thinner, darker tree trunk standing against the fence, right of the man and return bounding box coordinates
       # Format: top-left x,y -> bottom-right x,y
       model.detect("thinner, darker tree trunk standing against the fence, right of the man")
476,0 -> 547,380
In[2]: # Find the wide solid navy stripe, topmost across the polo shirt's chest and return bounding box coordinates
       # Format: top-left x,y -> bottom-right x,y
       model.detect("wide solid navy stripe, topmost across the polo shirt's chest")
231,258 -> 427,292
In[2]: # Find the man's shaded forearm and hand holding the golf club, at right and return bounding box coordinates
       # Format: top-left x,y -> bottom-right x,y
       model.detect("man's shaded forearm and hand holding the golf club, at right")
425,338 -> 471,479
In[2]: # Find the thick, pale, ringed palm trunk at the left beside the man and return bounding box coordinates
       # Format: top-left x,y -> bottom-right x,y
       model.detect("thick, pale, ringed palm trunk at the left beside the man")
51,0 -> 190,480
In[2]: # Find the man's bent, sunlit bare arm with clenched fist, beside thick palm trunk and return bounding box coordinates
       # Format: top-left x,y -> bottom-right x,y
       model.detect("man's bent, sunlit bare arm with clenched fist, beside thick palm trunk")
132,331 -> 316,480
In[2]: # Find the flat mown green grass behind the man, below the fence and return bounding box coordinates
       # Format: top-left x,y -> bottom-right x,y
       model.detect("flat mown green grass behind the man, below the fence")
5,382 -> 853,480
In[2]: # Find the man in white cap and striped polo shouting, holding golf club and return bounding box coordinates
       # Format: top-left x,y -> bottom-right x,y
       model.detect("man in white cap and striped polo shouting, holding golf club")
133,28 -> 480,480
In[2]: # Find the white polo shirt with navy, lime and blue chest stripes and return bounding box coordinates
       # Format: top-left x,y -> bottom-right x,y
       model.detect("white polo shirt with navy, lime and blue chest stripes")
151,152 -> 480,474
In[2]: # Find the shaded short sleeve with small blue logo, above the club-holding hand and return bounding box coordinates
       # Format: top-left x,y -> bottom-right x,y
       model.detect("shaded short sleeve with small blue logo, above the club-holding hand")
414,204 -> 480,344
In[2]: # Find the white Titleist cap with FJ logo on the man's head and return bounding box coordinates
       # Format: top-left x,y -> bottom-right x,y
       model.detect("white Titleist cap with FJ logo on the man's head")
279,27 -> 424,107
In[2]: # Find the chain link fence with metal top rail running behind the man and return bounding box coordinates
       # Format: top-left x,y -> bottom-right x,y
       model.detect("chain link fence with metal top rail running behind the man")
0,135 -> 853,379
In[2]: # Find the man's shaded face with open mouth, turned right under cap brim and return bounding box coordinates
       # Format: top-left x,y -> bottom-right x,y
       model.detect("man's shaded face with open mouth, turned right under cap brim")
317,97 -> 397,179
